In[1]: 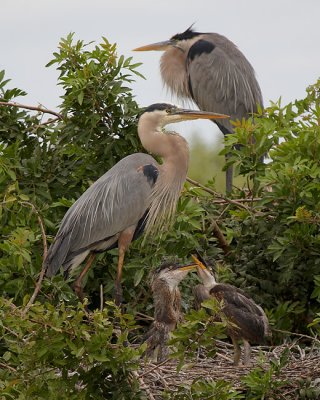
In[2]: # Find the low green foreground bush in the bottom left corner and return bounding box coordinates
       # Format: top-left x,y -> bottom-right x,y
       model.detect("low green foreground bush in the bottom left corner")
0,299 -> 143,400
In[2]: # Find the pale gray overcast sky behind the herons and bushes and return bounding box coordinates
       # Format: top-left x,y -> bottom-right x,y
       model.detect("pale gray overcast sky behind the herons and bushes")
0,0 -> 320,144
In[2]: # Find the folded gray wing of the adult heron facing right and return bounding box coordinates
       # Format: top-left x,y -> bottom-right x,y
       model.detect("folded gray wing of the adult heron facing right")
46,153 -> 157,276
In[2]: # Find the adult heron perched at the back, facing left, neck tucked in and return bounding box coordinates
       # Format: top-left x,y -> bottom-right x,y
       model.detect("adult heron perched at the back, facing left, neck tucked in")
134,27 -> 263,192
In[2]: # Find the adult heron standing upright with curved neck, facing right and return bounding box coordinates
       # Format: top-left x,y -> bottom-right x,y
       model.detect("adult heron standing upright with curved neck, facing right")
45,103 -> 227,304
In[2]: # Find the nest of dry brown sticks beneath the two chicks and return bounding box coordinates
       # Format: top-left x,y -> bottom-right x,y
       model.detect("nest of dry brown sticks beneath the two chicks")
135,342 -> 320,400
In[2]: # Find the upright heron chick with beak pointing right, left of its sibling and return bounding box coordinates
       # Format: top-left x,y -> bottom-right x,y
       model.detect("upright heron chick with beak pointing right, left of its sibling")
146,262 -> 195,362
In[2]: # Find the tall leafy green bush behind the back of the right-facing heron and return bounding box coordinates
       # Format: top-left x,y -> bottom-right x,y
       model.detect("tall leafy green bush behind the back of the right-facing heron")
0,34 -> 141,304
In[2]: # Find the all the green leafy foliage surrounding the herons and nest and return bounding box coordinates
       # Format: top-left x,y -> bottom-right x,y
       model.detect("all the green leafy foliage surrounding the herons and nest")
0,34 -> 320,399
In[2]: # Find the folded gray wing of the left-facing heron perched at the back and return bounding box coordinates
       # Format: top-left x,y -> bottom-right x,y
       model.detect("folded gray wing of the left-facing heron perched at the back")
187,34 -> 263,130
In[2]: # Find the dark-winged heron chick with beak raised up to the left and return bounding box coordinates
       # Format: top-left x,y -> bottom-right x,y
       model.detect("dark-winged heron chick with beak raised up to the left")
193,256 -> 271,365
